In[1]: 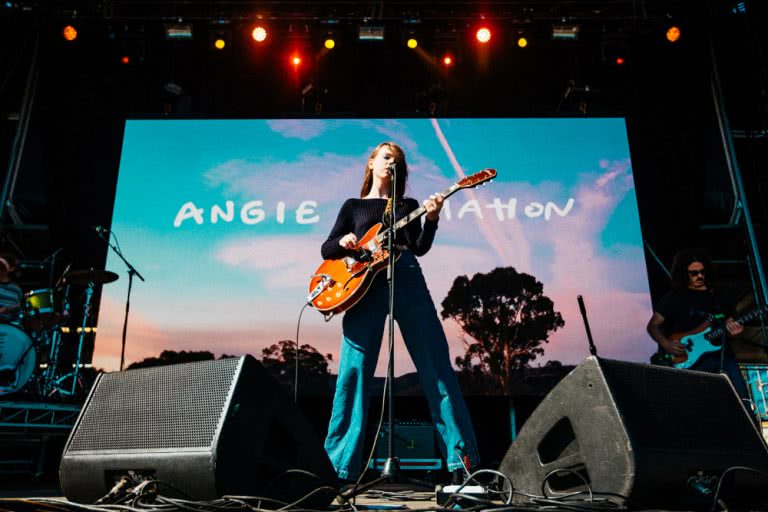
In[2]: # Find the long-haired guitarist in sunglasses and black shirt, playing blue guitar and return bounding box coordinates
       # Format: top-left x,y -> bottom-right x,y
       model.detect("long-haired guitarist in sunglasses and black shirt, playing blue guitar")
647,250 -> 749,399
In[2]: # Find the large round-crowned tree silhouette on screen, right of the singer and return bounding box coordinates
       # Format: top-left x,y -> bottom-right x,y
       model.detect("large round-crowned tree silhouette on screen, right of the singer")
440,267 -> 565,393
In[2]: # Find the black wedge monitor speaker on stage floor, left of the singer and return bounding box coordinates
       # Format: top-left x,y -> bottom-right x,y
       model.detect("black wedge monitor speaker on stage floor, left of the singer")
59,356 -> 335,504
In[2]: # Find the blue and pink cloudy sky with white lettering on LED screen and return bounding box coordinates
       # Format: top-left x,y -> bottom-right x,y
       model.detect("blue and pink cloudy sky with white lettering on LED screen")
93,118 -> 655,384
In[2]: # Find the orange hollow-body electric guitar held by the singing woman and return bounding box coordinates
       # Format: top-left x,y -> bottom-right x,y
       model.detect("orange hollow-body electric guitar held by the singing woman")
307,169 -> 496,322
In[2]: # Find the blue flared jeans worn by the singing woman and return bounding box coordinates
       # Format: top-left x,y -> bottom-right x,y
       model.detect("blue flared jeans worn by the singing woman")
325,251 -> 479,480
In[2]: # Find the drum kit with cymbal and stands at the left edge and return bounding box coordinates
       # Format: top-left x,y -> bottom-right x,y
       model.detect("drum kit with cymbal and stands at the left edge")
0,268 -> 118,397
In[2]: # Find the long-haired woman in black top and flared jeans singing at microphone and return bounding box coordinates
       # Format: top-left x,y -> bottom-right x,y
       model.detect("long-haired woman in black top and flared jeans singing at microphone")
321,142 -> 479,481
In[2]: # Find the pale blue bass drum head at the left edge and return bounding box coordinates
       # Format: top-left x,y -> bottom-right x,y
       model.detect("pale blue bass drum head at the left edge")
0,324 -> 37,396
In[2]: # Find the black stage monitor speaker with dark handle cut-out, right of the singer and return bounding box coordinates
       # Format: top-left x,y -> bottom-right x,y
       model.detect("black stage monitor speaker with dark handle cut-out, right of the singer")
499,357 -> 768,508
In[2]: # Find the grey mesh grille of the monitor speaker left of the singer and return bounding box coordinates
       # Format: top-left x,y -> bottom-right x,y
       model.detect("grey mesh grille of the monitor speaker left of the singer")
69,358 -> 242,452
